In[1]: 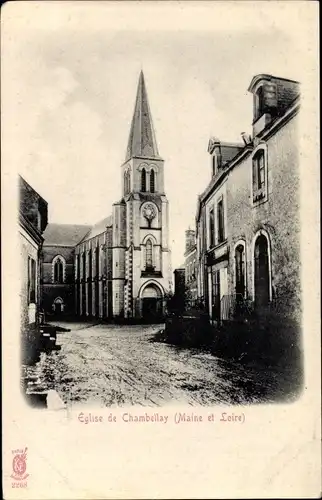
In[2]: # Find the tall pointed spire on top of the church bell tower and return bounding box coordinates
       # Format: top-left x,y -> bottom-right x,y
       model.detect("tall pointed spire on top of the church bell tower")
125,71 -> 160,161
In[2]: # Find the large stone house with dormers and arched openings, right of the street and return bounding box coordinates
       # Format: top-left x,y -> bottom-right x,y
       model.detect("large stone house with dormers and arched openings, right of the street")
196,74 -> 301,322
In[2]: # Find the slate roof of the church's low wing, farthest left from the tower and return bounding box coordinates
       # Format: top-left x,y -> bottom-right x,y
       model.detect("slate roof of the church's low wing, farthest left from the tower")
43,223 -> 90,247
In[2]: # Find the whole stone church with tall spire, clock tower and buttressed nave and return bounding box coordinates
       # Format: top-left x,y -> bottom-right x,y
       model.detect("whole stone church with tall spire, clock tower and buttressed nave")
41,71 -> 172,321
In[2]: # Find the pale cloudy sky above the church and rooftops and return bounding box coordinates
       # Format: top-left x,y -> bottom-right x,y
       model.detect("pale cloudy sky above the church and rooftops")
2,2 -> 310,269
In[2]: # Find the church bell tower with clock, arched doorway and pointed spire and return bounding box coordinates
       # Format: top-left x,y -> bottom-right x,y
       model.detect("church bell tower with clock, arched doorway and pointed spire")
120,71 -> 172,321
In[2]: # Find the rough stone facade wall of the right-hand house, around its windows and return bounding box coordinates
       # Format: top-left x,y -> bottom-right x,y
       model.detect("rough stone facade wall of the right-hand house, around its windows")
227,113 -> 301,319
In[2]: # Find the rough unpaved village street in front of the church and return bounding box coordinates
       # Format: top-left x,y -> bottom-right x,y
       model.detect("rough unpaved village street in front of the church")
35,324 -> 296,407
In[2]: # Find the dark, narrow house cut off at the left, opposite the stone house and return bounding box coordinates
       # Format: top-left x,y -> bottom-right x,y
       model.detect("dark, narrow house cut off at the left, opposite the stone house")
19,177 -> 48,363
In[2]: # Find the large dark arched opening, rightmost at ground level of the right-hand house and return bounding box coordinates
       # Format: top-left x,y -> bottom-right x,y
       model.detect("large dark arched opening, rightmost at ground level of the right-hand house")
254,234 -> 270,307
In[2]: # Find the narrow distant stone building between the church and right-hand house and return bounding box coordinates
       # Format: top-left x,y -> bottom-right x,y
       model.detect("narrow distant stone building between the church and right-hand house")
184,229 -> 198,305
